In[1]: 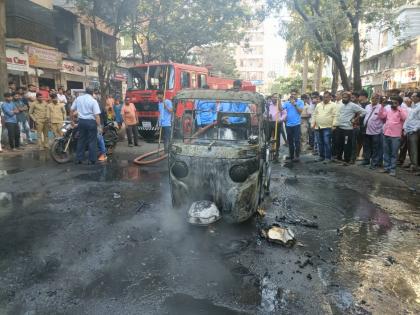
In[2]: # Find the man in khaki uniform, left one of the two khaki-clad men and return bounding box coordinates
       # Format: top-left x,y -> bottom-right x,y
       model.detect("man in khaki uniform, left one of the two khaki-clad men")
29,93 -> 48,150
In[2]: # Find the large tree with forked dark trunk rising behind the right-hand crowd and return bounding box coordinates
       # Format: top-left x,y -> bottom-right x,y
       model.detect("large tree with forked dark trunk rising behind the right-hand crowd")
268,0 -> 413,89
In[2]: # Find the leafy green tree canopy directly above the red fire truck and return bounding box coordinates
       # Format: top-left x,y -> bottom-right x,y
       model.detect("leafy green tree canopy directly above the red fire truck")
127,0 -> 252,62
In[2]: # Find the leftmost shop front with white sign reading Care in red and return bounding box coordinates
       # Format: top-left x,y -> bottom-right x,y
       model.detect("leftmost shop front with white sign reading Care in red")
6,48 -> 30,86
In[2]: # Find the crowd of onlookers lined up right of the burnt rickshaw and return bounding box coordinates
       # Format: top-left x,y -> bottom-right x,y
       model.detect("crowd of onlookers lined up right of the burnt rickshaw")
266,90 -> 420,176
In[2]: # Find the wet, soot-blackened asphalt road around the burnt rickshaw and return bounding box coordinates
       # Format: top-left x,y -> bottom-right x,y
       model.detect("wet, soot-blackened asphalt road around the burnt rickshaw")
0,144 -> 420,315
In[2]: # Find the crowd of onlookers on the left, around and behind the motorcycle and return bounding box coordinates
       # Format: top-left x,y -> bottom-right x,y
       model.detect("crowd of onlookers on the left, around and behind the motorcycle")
0,82 -> 143,160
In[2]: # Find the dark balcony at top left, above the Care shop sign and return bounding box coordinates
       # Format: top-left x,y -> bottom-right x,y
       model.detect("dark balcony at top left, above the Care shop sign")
6,0 -> 55,47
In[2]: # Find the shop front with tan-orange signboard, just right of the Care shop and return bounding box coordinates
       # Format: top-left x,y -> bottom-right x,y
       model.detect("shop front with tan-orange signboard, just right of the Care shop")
27,46 -> 61,89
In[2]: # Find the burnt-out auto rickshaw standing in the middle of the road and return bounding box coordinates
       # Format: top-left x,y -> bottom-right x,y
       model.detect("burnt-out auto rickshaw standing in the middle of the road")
168,90 -> 271,225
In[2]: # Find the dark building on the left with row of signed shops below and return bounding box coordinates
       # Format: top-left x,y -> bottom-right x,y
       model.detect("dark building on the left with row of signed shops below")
6,0 -> 126,93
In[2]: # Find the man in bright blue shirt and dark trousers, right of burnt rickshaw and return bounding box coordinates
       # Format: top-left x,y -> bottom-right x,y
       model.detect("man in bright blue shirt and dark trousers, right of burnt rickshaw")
283,90 -> 304,162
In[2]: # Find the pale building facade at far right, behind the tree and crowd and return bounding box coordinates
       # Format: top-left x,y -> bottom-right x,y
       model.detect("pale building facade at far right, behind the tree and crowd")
361,5 -> 420,92
